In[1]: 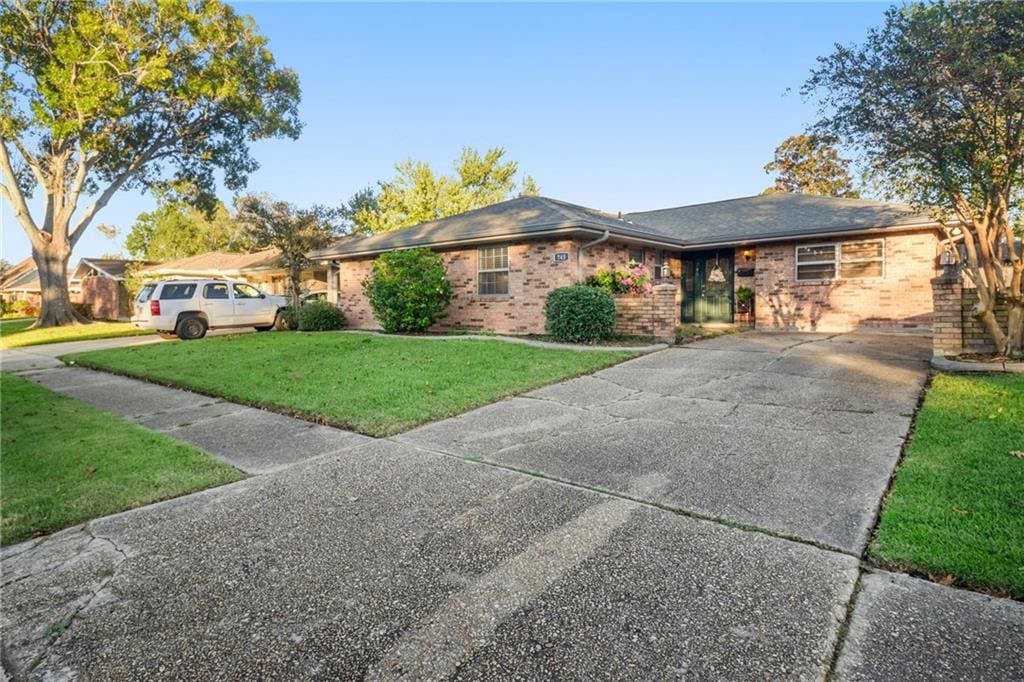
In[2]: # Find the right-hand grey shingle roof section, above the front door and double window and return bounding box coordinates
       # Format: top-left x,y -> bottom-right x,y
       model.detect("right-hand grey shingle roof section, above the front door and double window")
625,193 -> 934,244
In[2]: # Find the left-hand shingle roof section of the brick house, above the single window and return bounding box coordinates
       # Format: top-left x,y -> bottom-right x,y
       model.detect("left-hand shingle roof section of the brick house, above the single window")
310,197 -> 684,258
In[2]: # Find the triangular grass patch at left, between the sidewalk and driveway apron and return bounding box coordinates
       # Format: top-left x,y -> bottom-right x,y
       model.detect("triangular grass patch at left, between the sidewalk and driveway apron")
0,374 -> 245,545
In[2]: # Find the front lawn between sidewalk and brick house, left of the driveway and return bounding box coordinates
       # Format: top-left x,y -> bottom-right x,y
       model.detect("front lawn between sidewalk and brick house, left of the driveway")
66,332 -> 632,436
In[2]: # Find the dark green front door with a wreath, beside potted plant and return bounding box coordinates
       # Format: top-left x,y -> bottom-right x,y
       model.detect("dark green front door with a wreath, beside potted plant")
681,249 -> 733,324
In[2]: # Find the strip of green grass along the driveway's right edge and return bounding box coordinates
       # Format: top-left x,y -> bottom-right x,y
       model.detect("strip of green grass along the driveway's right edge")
869,375 -> 1024,597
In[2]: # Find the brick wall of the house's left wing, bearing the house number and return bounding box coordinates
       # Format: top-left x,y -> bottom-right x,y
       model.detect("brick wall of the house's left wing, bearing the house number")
338,240 -> 680,336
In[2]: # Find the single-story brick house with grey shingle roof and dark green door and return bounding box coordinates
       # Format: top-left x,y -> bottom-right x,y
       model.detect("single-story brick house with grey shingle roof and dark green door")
311,194 -> 941,335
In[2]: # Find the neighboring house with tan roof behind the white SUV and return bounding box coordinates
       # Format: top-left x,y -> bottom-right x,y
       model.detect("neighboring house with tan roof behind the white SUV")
141,249 -> 327,294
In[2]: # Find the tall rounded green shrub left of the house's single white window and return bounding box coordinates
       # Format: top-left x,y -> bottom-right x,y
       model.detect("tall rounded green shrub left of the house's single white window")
362,249 -> 452,333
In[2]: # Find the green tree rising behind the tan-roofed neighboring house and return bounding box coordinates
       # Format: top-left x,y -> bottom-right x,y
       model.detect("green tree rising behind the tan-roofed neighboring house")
125,186 -> 255,260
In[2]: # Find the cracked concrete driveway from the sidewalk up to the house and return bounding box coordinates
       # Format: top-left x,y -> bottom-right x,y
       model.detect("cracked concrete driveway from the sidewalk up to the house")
397,333 -> 931,554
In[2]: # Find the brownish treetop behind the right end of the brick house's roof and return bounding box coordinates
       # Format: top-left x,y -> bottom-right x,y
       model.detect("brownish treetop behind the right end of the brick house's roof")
761,135 -> 860,198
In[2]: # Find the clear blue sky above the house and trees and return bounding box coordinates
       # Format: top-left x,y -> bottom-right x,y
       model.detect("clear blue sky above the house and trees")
2,3 -> 887,261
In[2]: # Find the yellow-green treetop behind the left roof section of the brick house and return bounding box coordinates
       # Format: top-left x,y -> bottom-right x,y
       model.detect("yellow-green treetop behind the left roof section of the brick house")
342,146 -> 540,233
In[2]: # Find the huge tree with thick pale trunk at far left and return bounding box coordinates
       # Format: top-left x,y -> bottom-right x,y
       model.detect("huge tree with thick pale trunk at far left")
0,0 -> 301,327
